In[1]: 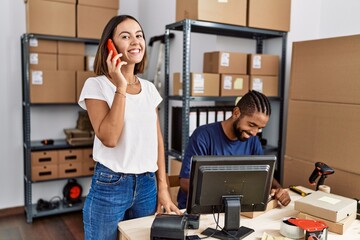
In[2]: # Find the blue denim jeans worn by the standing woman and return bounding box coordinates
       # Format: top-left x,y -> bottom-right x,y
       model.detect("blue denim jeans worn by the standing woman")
83,163 -> 157,240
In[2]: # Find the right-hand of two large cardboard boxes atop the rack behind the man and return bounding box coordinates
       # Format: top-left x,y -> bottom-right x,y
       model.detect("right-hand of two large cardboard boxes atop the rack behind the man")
247,0 -> 291,32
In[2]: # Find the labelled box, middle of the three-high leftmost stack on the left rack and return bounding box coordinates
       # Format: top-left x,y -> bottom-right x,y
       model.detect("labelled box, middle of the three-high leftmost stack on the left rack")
29,52 -> 57,70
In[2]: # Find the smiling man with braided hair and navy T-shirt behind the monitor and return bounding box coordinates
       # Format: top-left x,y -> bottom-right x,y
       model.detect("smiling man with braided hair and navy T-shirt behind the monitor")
178,91 -> 291,209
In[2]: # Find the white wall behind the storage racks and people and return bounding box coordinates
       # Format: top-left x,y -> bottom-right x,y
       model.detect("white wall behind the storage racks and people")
0,0 -> 360,209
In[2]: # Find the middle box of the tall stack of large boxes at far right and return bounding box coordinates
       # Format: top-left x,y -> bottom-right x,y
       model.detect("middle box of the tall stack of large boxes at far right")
286,100 -> 360,174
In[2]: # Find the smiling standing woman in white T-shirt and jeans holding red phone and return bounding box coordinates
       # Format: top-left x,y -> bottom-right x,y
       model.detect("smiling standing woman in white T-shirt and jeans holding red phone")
79,15 -> 180,240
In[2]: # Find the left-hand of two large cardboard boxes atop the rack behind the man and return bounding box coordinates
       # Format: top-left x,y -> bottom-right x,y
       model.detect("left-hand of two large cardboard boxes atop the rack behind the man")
176,0 -> 247,26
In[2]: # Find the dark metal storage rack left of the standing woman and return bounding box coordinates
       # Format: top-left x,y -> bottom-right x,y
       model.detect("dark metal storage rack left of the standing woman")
21,33 -> 99,223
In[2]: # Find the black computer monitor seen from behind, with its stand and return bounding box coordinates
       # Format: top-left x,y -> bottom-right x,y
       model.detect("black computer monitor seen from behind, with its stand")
186,155 -> 276,239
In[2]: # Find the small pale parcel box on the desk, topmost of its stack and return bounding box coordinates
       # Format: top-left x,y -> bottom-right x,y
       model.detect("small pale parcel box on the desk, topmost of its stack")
294,191 -> 357,222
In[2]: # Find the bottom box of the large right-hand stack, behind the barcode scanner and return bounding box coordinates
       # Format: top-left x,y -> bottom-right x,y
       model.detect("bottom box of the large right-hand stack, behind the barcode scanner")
283,156 -> 360,205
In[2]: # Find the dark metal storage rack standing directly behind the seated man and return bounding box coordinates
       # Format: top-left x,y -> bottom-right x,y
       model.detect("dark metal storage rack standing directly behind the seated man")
164,19 -> 287,183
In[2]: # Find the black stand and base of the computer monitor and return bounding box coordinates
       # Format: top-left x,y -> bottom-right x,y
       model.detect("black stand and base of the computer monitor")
201,196 -> 254,240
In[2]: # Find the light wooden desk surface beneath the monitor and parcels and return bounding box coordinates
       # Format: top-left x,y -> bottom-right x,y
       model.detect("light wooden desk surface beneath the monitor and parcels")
118,192 -> 360,240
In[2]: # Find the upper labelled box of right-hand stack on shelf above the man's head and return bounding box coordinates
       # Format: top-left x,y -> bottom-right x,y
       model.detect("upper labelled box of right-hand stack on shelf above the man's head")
248,54 -> 280,76
